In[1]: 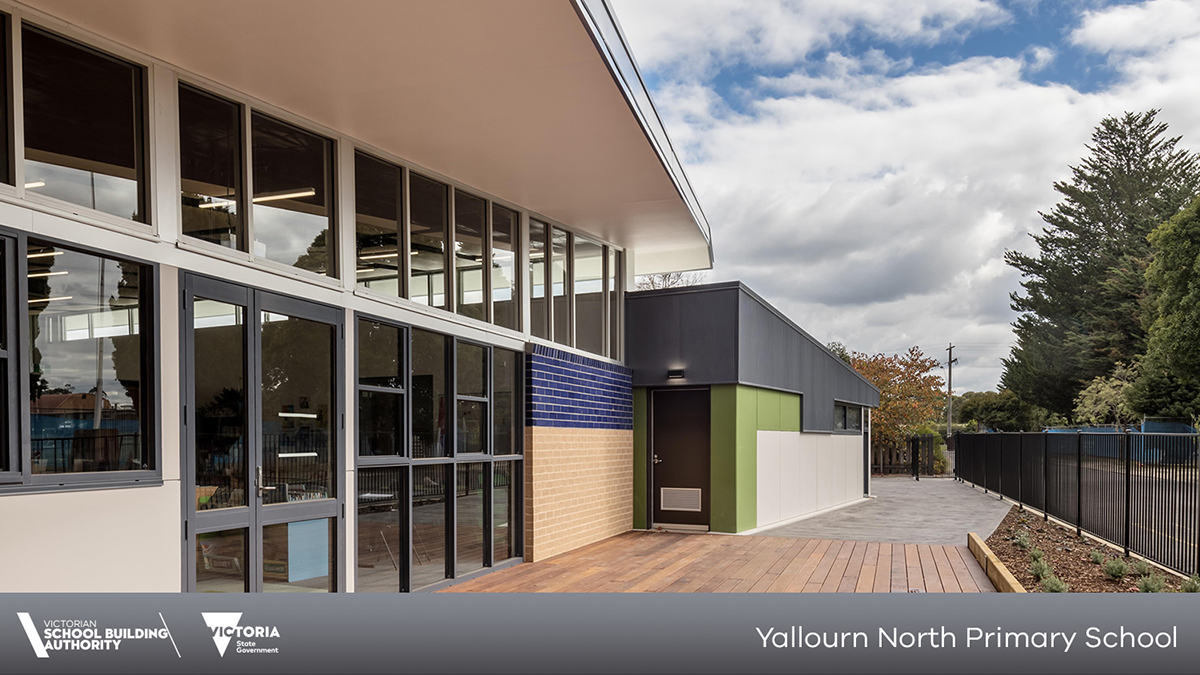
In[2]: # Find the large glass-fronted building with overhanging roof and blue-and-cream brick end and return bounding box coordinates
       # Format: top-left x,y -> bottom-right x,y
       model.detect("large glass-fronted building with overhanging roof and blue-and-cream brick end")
0,0 -> 710,592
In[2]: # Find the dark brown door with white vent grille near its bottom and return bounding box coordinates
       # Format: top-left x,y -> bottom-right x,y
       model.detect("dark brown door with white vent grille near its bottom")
650,389 -> 709,528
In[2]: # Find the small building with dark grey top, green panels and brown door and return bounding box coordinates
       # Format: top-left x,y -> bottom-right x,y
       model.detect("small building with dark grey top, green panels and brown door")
625,281 -> 880,532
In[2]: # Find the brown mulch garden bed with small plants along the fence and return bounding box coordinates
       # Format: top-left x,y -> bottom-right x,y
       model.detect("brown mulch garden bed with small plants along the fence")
988,507 -> 1182,593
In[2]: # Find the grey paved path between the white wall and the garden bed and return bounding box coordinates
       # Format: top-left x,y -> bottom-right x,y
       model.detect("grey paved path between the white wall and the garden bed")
756,477 -> 1010,545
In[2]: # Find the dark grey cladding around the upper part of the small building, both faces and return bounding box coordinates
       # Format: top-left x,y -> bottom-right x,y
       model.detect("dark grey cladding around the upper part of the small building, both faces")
625,281 -> 880,431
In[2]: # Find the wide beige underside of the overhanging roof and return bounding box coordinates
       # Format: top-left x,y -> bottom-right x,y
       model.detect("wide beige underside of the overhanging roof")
28,0 -> 708,274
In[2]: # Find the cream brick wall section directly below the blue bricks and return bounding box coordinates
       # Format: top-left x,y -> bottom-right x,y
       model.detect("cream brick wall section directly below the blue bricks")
524,426 -> 634,562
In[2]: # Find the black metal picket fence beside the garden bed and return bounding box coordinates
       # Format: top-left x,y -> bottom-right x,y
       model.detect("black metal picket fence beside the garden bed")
954,431 -> 1200,574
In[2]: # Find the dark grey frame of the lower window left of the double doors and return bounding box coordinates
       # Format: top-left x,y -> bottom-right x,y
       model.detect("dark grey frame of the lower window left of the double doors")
0,227 -> 162,495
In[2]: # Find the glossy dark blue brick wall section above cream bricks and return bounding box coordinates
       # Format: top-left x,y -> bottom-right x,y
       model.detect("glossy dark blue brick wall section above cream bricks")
526,345 -> 634,429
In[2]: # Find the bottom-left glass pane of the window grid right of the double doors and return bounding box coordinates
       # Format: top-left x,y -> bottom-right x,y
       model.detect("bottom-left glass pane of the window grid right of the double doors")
354,467 -> 408,593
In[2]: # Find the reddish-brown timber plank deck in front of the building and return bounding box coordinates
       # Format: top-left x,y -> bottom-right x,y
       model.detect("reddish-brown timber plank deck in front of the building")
442,531 -> 995,593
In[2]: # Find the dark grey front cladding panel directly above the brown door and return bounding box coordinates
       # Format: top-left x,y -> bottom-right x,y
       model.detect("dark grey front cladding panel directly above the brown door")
625,285 -> 739,387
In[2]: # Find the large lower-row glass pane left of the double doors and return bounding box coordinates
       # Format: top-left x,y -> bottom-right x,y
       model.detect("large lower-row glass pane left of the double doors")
26,239 -> 154,473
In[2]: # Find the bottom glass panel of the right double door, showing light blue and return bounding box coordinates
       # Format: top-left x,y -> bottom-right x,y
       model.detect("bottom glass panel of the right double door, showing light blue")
263,518 -> 335,593
